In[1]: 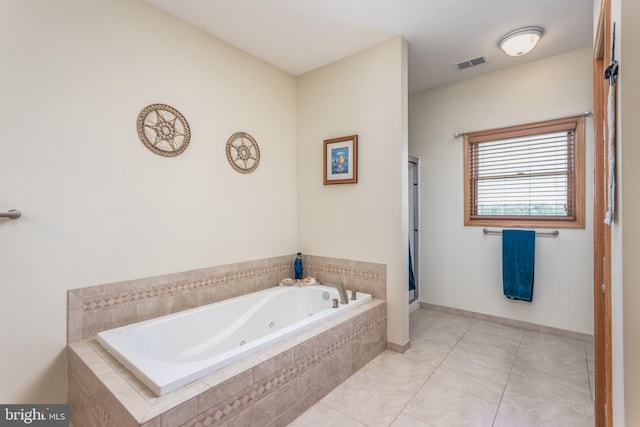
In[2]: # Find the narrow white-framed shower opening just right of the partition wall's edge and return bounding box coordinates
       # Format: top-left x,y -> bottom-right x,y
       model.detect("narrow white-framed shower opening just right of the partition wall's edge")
408,156 -> 420,313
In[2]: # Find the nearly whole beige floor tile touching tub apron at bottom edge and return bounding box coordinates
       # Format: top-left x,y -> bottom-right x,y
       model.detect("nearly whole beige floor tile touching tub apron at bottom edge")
321,372 -> 413,427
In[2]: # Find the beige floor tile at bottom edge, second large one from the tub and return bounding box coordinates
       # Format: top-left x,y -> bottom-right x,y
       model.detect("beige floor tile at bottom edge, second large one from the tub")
403,381 -> 498,427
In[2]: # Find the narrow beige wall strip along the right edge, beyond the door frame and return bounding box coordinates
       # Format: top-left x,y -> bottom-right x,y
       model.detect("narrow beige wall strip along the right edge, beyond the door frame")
612,0 -> 640,426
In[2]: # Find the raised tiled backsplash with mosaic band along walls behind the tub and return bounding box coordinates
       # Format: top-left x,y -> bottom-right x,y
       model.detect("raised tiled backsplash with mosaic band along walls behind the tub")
67,254 -> 387,343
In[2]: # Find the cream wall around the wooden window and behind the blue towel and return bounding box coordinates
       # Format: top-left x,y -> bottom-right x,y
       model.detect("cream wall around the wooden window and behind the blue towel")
409,48 -> 593,334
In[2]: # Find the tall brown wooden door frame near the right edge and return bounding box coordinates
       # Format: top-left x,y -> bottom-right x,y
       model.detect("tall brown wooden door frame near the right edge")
593,0 -> 612,427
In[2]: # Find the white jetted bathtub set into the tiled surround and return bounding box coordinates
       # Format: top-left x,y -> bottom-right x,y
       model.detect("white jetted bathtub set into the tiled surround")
97,285 -> 371,396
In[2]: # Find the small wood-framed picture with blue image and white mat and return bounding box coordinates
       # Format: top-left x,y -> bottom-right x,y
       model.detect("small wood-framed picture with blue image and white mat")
323,135 -> 358,185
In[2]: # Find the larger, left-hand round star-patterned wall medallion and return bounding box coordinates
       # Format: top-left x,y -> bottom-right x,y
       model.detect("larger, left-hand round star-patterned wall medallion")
137,104 -> 191,157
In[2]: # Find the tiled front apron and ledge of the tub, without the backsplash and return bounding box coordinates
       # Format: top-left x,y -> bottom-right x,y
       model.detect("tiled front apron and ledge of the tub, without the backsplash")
68,299 -> 387,427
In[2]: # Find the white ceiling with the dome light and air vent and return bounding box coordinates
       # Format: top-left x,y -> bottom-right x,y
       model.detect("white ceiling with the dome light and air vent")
145,0 -> 593,93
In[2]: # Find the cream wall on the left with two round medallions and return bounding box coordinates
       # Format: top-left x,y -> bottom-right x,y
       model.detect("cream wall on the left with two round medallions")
0,0 -> 297,403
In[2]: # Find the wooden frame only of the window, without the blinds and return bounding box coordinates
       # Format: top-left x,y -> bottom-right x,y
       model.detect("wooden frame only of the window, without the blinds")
464,115 -> 585,228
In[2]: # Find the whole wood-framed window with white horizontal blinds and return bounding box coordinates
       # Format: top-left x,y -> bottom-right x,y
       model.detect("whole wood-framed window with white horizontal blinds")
464,116 -> 584,228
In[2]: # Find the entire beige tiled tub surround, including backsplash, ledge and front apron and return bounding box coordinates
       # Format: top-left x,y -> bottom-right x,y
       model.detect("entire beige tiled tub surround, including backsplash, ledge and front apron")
67,255 -> 386,427
